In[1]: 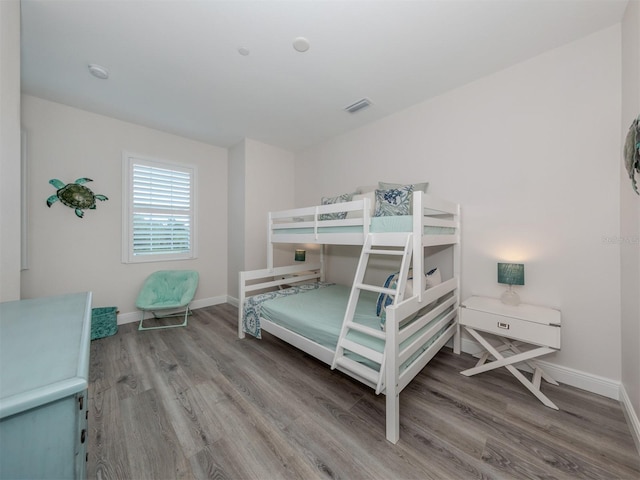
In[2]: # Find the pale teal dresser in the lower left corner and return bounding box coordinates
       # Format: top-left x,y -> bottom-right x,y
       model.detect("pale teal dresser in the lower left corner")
0,293 -> 91,479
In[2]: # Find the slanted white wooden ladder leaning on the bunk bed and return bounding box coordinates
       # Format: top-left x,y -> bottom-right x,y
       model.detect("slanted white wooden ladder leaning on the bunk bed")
331,233 -> 413,394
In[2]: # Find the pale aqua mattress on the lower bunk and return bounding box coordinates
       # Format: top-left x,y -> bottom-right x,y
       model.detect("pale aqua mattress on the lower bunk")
261,285 -> 448,369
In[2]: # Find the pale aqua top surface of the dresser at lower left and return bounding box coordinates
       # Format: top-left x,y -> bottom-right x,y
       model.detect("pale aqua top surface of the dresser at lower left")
0,292 -> 91,418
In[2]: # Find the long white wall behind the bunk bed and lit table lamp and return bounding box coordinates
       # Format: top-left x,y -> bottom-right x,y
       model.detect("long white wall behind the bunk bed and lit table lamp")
296,26 -> 621,380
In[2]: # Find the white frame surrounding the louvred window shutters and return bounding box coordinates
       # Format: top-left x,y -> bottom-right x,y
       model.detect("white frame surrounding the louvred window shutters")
122,152 -> 198,263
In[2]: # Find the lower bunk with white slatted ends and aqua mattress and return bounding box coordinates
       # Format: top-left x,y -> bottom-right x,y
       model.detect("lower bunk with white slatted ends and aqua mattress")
238,266 -> 459,443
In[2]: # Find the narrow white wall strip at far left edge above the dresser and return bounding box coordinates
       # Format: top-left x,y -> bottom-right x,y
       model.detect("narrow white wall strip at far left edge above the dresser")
0,0 -> 21,302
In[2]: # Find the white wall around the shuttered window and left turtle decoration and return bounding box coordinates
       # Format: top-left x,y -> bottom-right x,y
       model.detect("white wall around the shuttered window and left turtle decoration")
22,96 -> 227,314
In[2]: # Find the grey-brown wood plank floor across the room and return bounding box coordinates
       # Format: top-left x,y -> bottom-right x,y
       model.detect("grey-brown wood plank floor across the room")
87,305 -> 640,480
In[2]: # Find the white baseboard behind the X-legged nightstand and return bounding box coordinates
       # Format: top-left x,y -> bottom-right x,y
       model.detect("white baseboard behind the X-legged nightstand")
462,337 -> 622,400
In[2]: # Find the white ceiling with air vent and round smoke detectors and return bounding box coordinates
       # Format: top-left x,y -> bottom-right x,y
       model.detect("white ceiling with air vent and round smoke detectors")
21,0 -> 627,151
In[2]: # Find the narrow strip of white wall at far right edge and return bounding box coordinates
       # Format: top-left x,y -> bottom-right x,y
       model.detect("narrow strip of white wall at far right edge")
620,1 -> 640,442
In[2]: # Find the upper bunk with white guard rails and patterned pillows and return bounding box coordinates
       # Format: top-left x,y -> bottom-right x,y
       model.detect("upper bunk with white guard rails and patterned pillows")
268,185 -> 460,246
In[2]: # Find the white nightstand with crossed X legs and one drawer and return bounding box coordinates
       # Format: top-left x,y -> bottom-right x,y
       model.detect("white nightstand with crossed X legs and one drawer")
459,297 -> 561,410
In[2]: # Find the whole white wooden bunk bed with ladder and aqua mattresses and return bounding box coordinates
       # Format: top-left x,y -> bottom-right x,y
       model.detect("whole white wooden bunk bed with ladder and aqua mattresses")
238,190 -> 460,443
